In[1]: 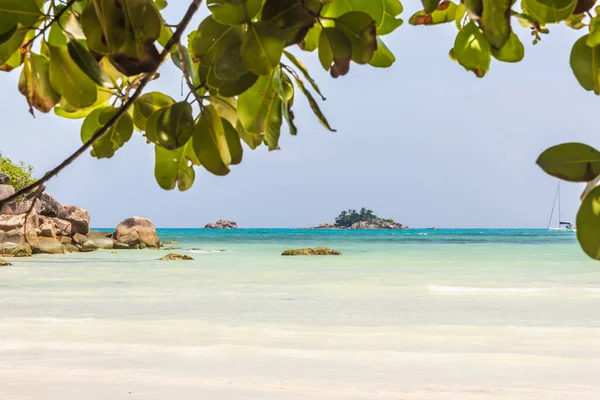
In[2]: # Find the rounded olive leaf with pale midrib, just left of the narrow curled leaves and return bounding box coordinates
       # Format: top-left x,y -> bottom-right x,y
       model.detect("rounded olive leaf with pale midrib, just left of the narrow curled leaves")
241,21 -> 285,75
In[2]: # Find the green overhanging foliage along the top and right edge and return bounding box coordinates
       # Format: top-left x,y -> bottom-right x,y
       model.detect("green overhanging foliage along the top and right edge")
0,0 -> 600,259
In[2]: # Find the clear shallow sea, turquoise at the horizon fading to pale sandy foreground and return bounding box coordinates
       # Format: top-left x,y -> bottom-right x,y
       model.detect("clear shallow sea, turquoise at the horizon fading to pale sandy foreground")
0,230 -> 600,400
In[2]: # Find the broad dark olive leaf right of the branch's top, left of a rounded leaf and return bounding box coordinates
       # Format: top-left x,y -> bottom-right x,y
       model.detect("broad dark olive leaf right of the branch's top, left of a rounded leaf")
191,17 -> 242,66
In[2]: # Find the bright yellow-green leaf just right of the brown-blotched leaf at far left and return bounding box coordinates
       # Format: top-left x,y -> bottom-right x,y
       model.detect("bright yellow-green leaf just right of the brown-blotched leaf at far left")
48,45 -> 98,108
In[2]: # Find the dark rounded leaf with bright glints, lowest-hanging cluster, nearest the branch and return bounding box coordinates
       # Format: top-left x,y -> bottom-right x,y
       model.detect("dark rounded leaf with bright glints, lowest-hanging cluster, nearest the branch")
146,101 -> 194,150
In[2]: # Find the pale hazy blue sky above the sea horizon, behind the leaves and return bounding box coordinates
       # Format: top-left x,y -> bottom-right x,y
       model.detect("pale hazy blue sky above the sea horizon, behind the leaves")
0,1 -> 600,228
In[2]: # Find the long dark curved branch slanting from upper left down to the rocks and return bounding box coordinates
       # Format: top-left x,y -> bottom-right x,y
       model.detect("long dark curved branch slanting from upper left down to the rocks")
0,0 -> 202,207
